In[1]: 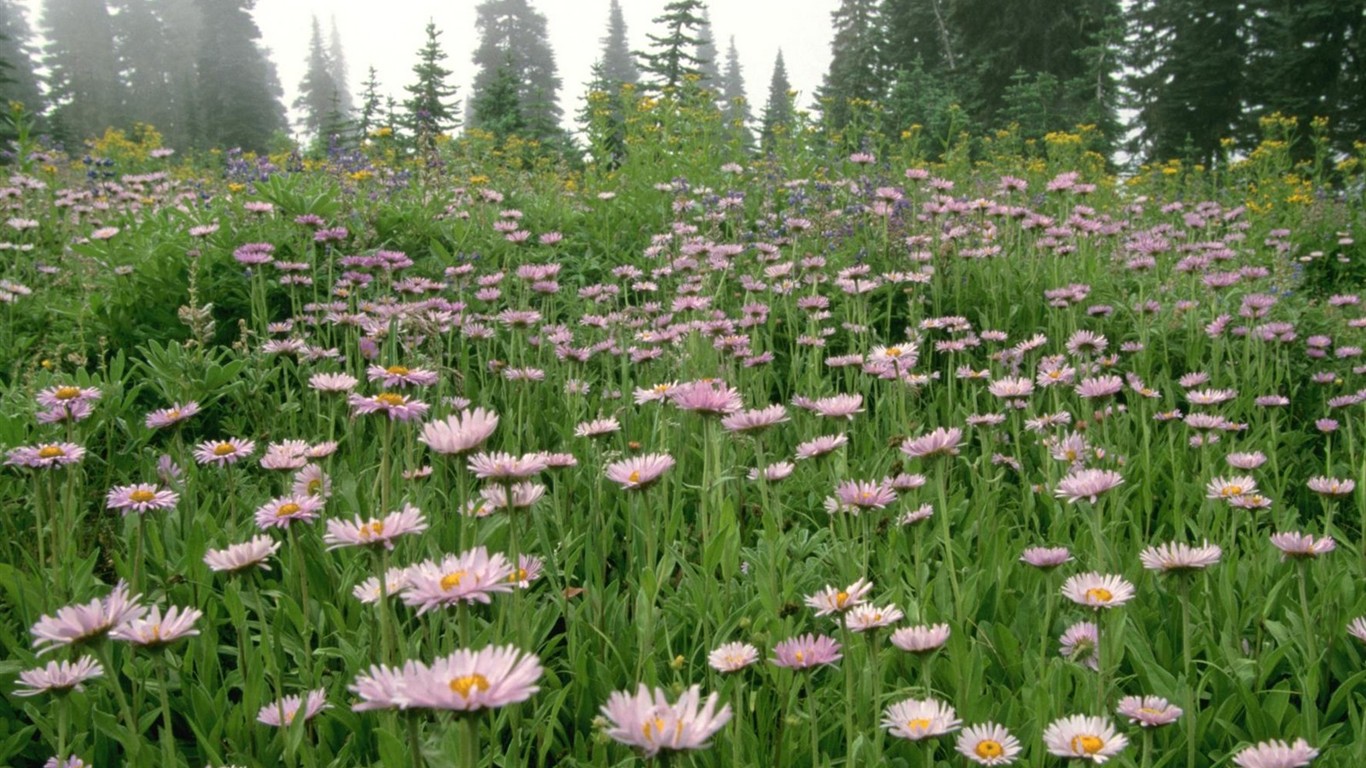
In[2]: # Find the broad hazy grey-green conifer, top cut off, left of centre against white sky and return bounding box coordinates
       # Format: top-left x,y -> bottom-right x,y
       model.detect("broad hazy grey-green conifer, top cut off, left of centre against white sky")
471,0 -> 564,141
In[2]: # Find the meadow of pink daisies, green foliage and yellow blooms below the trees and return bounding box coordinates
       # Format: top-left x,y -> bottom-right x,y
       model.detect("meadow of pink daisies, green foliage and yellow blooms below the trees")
0,100 -> 1366,768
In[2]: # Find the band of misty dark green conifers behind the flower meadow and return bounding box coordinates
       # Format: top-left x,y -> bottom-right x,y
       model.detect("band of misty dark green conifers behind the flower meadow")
0,0 -> 1366,164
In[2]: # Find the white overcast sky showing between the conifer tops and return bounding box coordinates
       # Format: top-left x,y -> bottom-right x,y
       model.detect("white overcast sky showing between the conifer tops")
255,0 -> 839,133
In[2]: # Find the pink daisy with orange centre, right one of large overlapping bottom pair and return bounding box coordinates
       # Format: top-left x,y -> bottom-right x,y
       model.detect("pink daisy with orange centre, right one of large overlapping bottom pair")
404,645 -> 544,712
